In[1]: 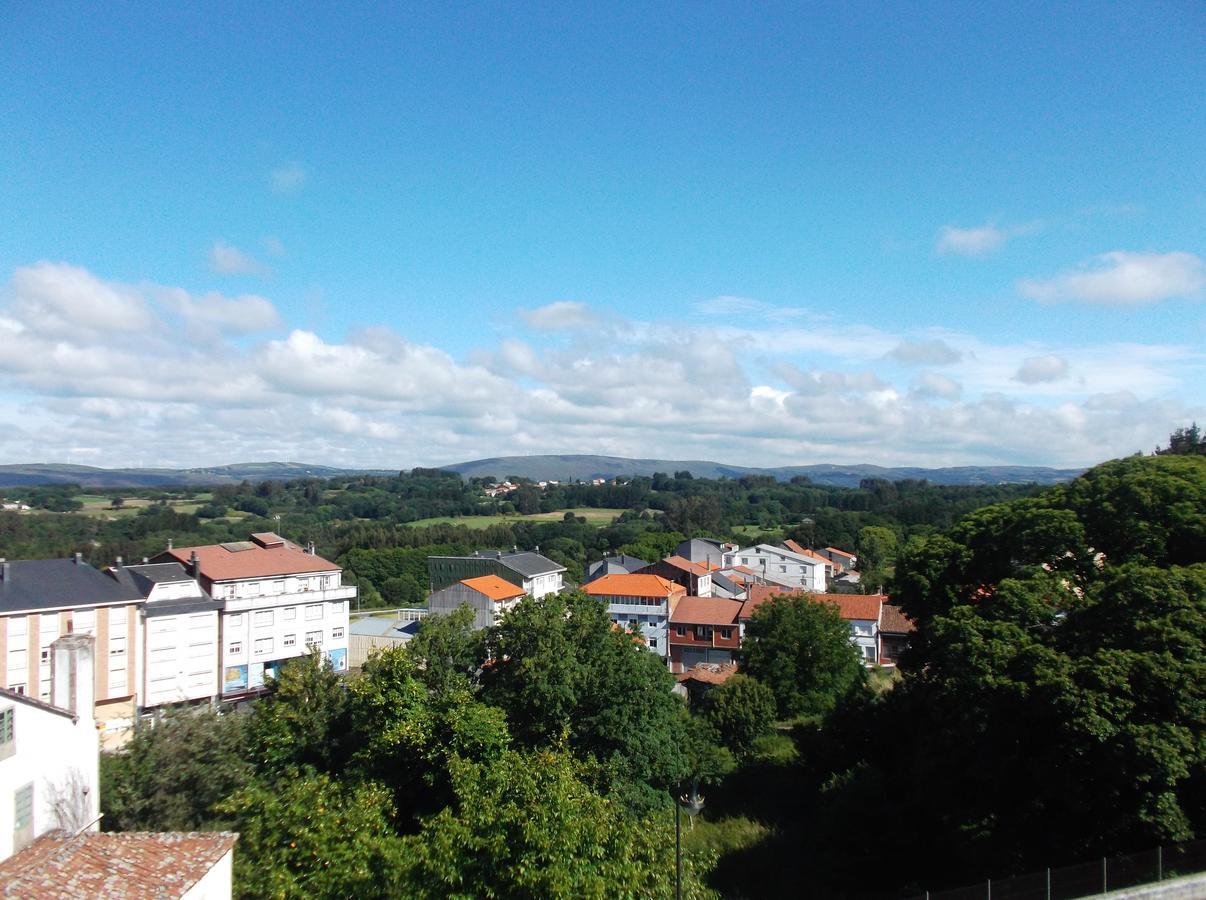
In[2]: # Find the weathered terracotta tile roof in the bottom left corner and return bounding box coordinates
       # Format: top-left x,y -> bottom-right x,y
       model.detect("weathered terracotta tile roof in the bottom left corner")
0,831 -> 239,900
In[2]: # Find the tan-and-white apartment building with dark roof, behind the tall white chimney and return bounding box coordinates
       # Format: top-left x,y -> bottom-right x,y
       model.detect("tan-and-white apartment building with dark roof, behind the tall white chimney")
0,554 -> 144,741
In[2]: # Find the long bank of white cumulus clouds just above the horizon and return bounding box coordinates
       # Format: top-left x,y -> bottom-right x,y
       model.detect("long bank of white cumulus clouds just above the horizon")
0,263 -> 1206,469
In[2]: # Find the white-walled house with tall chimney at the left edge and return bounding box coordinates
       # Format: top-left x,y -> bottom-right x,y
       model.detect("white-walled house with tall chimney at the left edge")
0,635 -> 100,858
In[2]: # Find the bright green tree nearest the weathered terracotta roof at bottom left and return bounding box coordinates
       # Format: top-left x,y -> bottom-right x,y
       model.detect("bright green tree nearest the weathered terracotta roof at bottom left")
218,772 -> 405,900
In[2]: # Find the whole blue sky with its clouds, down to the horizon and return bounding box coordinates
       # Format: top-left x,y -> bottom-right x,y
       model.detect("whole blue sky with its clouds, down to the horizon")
0,2 -> 1206,468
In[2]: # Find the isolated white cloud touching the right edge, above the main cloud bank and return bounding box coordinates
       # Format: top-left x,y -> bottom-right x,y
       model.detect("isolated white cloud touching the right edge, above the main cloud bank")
1018,250 -> 1206,306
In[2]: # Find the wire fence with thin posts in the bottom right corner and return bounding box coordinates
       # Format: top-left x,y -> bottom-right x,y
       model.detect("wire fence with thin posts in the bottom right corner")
908,841 -> 1206,900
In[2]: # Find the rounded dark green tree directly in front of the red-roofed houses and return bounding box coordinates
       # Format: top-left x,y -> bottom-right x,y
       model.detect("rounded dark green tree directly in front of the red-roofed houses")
742,595 -> 866,719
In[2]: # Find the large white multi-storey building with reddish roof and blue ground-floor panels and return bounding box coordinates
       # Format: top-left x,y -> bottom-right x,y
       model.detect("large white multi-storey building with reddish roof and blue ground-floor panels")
152,532 -> 356,700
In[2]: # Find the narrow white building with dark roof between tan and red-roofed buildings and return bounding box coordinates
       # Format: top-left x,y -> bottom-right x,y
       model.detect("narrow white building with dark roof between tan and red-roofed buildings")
109,557 -> 224,713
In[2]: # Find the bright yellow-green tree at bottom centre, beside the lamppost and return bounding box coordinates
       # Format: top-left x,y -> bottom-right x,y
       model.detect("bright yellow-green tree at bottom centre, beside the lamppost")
402,749 -> 710,898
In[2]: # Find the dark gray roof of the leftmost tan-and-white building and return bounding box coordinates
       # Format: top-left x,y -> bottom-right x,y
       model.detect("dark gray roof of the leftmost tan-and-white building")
0,560 -> 142,613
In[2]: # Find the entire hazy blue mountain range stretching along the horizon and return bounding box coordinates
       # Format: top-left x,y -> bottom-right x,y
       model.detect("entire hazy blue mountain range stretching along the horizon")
0,455 -> 1084,487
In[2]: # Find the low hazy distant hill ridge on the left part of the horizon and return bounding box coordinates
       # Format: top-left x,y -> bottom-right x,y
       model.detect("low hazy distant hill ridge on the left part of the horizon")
0,462 -> 397,487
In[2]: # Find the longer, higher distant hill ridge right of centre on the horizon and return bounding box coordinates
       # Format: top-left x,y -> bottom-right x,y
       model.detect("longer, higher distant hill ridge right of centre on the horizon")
440,455 -> 1084,487
